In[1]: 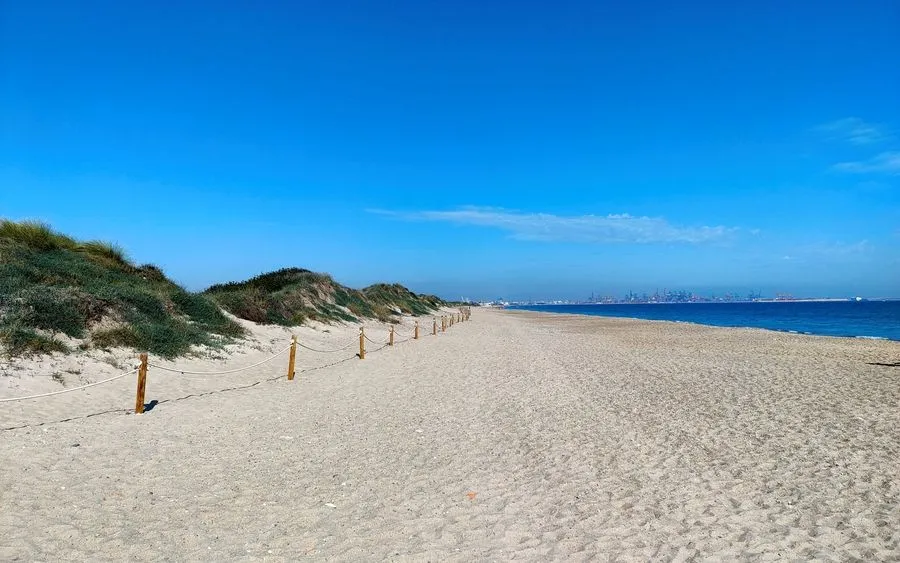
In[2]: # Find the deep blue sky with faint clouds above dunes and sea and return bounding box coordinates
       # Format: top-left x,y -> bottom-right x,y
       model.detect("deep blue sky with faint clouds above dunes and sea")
0,0 -> 900,299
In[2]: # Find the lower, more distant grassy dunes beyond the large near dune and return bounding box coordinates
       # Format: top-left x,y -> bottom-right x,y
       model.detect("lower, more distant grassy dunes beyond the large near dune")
204,268 -> 443,326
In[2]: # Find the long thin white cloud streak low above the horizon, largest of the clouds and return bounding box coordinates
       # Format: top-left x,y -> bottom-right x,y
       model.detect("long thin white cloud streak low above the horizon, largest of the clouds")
370,207 -> 737,244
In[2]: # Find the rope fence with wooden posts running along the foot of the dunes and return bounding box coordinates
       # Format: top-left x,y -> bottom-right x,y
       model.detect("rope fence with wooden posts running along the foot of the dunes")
0,307 -> 472,420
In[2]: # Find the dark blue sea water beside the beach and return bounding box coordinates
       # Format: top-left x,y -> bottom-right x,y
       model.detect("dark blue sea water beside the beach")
510,301 -> 900,341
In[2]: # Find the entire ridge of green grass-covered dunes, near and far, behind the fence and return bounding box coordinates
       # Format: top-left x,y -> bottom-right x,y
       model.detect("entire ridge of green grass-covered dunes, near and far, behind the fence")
0,220 -> 444,357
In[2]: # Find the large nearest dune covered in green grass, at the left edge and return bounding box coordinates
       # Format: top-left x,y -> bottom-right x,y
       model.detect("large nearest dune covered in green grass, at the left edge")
0,220 -> 244,357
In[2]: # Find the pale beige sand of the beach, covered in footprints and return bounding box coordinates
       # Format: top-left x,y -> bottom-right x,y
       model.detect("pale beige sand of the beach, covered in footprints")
0,309 -> 900,561
